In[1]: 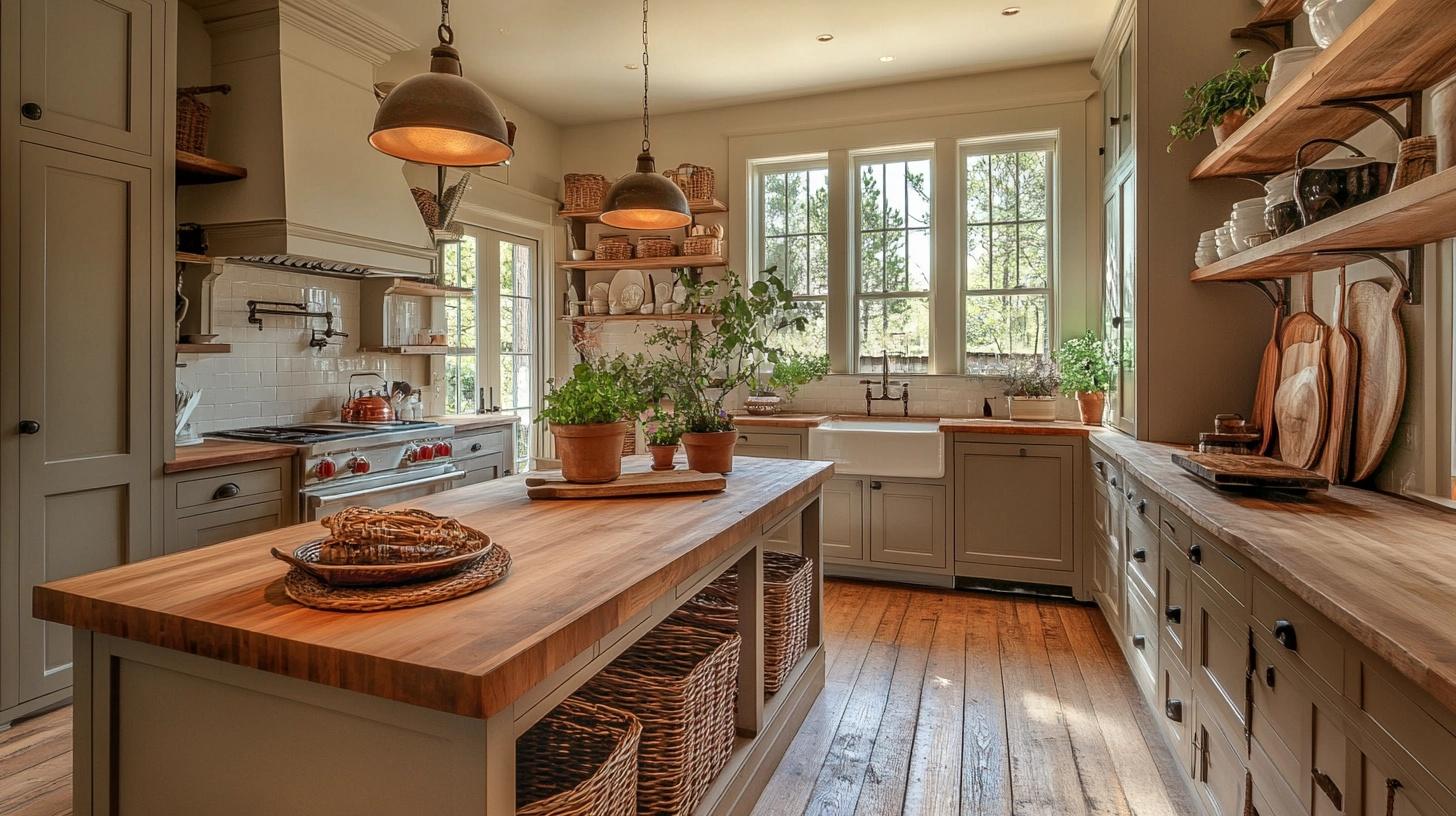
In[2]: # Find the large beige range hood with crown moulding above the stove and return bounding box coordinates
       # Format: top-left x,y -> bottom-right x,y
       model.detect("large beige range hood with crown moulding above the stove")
178,0 -> 437,278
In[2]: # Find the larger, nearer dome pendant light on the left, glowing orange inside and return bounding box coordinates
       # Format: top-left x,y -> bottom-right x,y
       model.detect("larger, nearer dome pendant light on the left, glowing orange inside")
368,0 -> 515,168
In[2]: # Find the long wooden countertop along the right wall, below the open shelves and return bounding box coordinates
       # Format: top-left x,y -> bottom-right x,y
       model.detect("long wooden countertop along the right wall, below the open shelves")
1092,430 -> 1456,711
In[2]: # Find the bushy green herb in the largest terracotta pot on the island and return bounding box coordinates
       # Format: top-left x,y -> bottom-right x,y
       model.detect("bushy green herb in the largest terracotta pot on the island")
539,358 -> 646,484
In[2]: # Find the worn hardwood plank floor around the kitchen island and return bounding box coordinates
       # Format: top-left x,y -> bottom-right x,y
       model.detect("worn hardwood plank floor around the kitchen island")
0,581 -> 1195,816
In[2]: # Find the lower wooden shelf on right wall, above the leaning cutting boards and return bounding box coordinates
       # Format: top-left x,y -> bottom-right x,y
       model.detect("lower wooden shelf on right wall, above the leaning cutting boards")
1190,169 -> 1456,283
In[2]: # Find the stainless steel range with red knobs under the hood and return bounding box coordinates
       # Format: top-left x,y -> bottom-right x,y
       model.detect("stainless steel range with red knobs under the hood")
207,421 -> 466,522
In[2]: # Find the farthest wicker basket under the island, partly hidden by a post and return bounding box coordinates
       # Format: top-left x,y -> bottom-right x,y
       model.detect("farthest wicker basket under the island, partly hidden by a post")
670,552 -> 814,694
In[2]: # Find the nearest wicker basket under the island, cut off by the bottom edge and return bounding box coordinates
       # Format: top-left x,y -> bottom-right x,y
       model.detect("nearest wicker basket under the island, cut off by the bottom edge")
515,697 -> 642,816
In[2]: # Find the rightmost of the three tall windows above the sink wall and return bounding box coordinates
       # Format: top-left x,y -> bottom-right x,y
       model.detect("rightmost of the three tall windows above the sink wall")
962,144 -> 1053,374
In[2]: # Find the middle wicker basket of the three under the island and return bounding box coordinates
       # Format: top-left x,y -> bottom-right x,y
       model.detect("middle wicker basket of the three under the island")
577,624 -> 743,815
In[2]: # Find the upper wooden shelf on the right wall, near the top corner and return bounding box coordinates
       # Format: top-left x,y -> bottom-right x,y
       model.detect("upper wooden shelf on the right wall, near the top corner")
1191,0 -> 1456,179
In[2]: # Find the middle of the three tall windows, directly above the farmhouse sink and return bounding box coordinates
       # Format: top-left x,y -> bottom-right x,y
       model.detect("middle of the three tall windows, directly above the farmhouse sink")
855,154 -> 930,373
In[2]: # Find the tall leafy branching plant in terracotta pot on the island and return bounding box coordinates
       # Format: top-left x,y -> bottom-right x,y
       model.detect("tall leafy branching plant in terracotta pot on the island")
646,268 -> 807,474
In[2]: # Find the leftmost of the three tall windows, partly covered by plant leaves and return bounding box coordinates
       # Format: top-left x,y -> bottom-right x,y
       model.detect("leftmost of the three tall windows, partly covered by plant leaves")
757,163 -> 828,356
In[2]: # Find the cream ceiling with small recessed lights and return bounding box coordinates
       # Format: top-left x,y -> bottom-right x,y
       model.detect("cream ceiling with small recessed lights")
352,0 -> 1115,125
